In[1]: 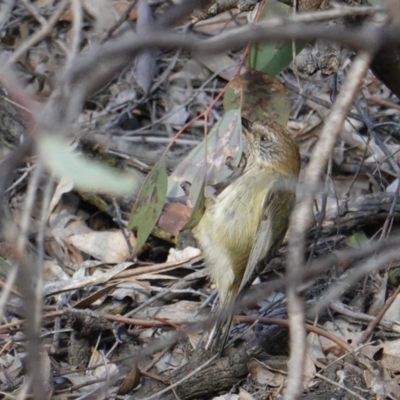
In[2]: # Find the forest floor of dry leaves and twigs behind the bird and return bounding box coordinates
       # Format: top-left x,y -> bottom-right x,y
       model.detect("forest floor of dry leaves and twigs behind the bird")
0,0 -> 400,400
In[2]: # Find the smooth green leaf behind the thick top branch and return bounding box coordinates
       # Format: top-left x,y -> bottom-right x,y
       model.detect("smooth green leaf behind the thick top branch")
248,0 -> 305,76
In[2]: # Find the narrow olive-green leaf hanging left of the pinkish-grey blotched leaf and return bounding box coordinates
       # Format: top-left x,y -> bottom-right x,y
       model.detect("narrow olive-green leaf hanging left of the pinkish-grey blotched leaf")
128,159 -> 168,253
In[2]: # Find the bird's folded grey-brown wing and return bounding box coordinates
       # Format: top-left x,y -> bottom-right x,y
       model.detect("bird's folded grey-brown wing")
238,181 -> 296,293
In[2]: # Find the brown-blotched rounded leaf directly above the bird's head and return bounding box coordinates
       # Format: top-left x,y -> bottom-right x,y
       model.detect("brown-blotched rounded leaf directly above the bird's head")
224,70 -> 290,127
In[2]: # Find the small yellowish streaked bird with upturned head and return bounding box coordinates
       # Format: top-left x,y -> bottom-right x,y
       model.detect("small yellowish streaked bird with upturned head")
193,119 -> 300,351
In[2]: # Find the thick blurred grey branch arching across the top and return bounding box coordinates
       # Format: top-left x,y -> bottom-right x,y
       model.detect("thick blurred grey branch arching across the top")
61,9 -> 388,102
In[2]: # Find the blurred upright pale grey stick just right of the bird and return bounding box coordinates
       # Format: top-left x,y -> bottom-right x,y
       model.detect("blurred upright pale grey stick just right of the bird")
284,49 -> 373,400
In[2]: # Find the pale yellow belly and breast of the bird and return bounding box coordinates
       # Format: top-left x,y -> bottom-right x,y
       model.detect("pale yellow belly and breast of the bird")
194,167 -> 275,301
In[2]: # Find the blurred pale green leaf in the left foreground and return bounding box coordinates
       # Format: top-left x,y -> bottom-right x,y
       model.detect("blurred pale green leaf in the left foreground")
38,134 -> 139,196
